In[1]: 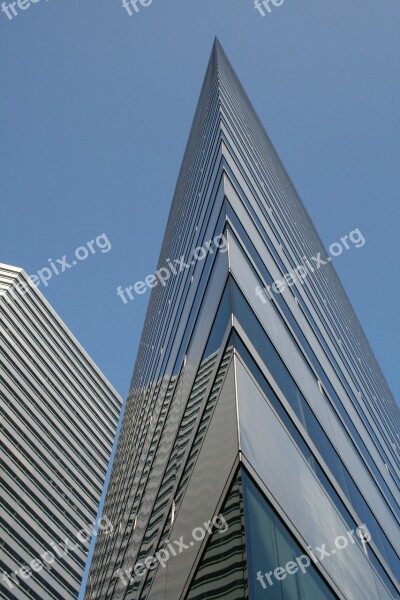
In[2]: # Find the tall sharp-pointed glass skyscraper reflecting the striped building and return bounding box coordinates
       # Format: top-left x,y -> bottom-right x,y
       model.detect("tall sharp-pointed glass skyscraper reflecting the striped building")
86,41 -> 400,600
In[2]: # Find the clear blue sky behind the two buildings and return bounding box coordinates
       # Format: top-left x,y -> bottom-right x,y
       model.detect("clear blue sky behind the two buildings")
0,0 -> 400,596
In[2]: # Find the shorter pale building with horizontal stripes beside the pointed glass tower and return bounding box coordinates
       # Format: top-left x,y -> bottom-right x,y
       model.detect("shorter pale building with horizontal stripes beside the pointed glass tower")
0,264 -> 122,600
